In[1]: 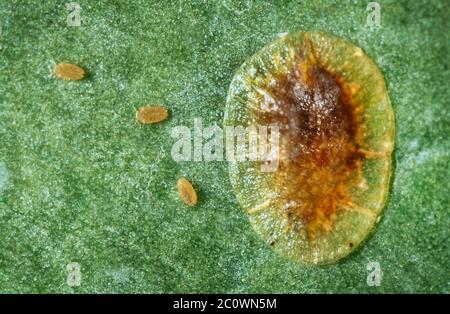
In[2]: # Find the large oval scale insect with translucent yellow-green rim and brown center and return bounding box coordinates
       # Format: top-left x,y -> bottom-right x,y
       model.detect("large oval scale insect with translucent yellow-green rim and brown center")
224,31 -> 395,264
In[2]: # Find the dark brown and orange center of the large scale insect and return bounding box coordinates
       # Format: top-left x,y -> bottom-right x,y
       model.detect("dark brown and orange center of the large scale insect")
256,63 -> 364,239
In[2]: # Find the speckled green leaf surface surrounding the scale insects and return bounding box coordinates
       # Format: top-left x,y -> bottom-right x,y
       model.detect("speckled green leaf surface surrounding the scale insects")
0,0 -> 450,293
